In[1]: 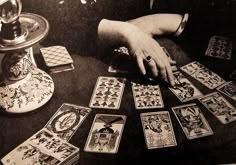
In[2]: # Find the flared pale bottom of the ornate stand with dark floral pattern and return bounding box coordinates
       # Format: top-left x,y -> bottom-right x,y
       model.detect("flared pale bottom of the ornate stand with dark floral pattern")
0,68 -> 54,113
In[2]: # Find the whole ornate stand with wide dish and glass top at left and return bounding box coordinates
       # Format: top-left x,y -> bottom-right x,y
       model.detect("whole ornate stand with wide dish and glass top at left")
0,0 -> 54,113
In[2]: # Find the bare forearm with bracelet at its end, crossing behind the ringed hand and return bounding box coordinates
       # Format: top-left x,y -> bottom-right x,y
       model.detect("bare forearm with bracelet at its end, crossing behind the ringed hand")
128,14 -> 183,36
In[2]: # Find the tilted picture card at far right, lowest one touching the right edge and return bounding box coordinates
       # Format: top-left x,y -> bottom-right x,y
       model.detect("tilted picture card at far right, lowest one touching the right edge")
199,92 -> 236,124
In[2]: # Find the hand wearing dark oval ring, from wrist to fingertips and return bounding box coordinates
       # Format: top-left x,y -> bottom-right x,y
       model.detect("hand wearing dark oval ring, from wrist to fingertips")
126,26 -> 176,86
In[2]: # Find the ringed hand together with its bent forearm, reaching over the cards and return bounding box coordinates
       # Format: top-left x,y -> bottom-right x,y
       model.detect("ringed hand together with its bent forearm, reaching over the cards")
98,19 -> 175,86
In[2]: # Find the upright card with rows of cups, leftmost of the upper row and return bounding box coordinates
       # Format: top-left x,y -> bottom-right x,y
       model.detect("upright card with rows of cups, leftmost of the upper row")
89,76 -> 126,109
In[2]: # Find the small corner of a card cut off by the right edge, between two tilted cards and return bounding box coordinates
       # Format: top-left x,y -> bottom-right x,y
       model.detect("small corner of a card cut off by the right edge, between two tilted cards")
217,81 -> 236,101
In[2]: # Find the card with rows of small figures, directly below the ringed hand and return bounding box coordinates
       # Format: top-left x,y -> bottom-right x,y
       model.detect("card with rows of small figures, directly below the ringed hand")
132,82 -> 164,109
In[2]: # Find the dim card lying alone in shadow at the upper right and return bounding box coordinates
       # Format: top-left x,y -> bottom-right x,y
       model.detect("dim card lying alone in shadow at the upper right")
205,36 -> 232,60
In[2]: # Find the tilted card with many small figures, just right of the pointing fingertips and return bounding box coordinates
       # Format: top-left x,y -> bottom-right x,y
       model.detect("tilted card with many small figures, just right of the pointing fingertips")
180,61 -> 225,89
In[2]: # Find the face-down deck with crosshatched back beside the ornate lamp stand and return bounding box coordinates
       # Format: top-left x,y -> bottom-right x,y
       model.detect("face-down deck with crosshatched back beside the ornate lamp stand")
40,46 -> 74,73
